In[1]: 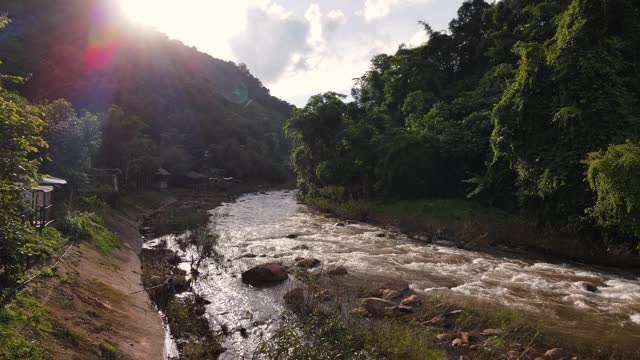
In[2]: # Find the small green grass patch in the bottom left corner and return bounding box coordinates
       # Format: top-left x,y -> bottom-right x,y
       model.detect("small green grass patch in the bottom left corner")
0,289 -> 51,360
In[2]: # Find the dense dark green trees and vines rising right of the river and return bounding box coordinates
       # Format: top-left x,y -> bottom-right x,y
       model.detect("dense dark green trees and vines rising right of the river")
287,0 -> 640,253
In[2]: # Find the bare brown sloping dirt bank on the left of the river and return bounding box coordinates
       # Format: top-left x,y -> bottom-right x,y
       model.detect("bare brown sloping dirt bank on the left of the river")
34,207 -> 164,360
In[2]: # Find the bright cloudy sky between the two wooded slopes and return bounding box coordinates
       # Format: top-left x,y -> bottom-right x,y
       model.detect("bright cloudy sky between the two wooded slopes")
120,0 -> 463,107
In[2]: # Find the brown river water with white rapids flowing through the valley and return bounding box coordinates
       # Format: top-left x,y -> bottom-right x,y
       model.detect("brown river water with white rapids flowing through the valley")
151,191 -> 640,359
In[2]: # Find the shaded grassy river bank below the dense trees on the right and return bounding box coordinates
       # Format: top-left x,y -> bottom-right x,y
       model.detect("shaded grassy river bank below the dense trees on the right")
304,198 -> 640,270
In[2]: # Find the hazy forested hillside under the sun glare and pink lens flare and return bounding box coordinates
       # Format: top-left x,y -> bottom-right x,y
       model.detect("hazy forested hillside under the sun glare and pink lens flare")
0,0 -> 292,188
